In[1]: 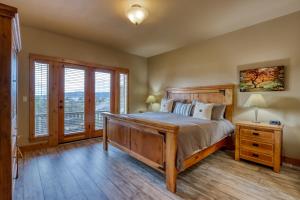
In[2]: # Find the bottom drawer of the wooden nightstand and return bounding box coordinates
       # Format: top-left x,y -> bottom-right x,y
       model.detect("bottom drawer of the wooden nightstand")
240,148 -> 273,166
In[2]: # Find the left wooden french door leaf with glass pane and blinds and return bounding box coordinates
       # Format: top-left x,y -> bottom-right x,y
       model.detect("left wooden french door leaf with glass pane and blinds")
58,65 -> 90,142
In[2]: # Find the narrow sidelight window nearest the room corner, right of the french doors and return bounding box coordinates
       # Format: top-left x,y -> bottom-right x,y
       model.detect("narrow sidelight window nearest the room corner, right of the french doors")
120,73 -> 128,114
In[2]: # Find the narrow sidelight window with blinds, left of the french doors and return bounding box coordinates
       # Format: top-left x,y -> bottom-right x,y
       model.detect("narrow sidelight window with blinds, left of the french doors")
34,62 -> 49,137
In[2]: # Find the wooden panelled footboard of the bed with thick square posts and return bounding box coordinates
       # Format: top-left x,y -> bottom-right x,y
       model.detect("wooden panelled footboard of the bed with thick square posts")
102,113 -> 179,192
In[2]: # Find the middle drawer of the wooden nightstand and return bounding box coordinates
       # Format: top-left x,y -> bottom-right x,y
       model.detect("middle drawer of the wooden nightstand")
240,139 -> 273,156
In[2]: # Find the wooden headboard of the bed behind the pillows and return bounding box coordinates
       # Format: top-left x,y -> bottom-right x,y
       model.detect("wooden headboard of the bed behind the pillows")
166,84 -> 234,121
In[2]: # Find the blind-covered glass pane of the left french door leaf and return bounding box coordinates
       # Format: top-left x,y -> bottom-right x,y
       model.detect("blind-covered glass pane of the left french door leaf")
64,67 -> 85,135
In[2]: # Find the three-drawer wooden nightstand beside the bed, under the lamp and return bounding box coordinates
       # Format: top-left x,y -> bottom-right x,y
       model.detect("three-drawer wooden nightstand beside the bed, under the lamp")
235,122 -> 283,172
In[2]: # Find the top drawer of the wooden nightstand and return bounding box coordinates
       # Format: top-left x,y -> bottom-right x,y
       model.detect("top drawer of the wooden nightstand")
240,128 -> 274,143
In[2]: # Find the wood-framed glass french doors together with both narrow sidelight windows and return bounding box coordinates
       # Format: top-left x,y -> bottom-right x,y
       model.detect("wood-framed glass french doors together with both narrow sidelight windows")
29,55 -> 128,145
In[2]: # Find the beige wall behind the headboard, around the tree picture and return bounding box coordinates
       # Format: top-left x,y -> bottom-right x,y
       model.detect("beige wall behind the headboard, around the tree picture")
148,12 -> 300,158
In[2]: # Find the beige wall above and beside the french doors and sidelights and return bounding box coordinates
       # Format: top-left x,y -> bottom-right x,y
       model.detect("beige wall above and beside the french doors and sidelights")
18,26 -> 148,145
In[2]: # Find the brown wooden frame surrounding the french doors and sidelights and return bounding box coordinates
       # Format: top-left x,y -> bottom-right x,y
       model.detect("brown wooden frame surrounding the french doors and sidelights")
29,53 -> 129,146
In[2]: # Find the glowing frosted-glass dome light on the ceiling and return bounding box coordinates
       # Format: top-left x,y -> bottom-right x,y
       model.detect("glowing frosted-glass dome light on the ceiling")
127,4 -> 148,25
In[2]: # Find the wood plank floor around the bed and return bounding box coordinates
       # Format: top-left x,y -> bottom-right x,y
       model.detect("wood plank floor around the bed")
14,139 -> 300,200
